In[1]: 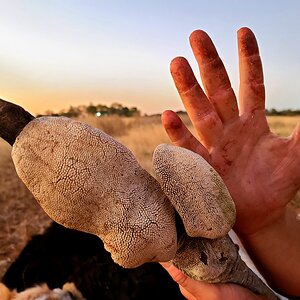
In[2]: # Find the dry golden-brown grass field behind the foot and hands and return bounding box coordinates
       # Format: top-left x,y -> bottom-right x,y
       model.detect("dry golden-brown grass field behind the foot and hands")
0,116 -> 300,278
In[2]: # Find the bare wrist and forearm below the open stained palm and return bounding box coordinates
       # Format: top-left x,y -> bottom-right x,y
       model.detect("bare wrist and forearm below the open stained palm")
238,206 -> 300,296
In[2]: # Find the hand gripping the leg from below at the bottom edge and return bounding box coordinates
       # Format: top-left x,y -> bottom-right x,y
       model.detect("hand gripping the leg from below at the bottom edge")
161,263 -> 267,300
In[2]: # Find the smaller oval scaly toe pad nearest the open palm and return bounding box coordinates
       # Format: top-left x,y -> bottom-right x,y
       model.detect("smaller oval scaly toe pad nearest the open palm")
153,144 -> 235,239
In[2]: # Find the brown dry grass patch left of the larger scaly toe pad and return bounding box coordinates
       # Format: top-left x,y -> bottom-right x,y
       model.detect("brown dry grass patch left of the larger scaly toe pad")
0,140 -> 50,278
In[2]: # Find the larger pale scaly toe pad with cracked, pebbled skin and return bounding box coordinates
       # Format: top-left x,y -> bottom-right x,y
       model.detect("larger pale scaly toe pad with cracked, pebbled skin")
12,117 -> 177,267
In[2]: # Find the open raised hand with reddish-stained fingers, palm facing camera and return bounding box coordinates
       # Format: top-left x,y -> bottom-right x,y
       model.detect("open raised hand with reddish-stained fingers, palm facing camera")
162,28 -> 300,235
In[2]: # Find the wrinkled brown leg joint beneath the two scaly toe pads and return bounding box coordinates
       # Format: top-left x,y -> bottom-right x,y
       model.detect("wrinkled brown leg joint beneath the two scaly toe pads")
172,234 -> 278,300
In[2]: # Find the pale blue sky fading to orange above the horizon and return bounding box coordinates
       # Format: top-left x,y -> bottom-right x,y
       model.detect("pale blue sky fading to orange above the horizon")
0,0 -> 300,114
